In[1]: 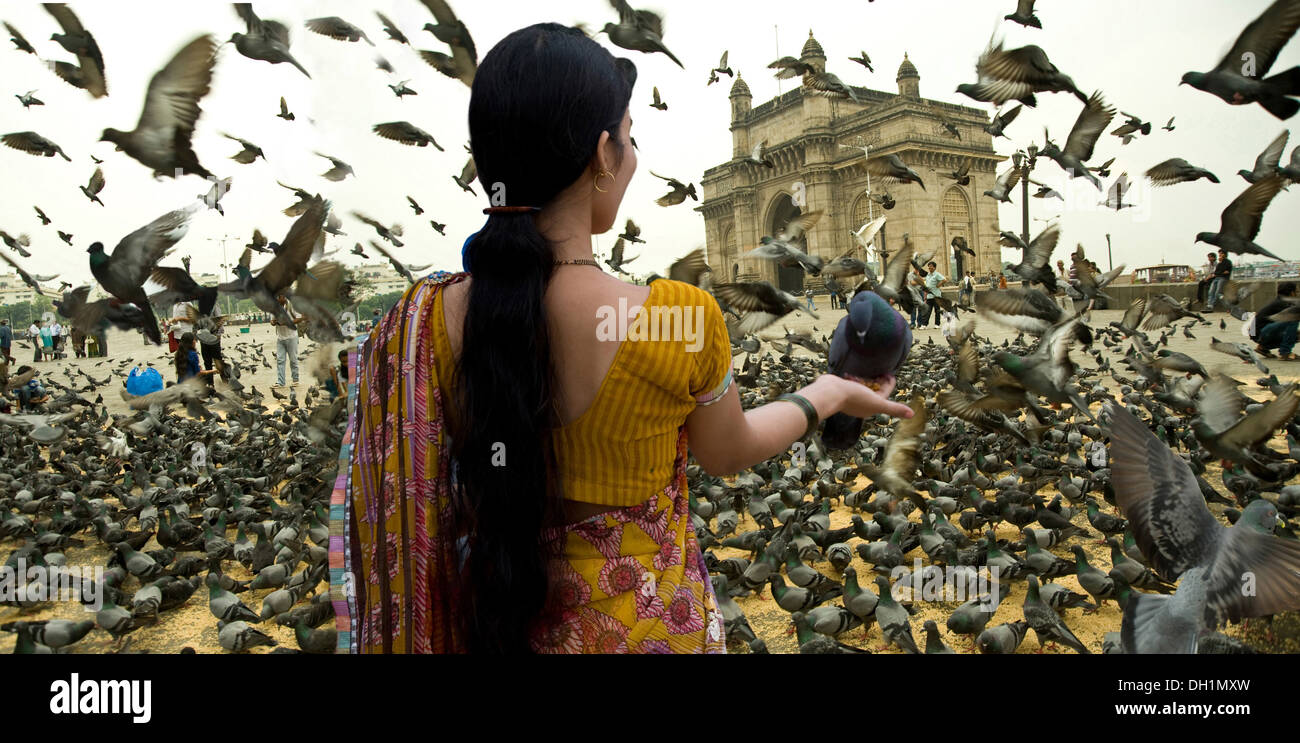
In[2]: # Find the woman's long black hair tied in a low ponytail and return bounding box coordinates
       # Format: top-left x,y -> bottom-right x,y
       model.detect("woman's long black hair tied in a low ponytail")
451,23 -> 636,653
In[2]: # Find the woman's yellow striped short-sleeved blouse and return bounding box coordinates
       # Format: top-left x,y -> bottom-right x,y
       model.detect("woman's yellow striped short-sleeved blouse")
433,279 -> 732,507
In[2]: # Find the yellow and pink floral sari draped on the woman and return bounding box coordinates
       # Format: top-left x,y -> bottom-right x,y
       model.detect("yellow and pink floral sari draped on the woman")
329,273 -> 725,653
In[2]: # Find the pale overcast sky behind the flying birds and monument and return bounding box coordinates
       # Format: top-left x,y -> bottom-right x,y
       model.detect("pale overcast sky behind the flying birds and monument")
0,0 -> 1300,289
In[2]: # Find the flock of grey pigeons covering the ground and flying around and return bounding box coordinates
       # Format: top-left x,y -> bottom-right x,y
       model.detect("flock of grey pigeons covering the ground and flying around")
0,0 -> 1300,652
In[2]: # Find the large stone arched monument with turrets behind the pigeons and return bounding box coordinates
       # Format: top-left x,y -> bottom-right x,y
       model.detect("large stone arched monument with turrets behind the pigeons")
696,31 -> 1004,291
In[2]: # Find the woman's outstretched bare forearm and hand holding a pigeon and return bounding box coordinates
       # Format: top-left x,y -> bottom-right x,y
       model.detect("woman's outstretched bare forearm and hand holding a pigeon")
686,374 -> 913,475
